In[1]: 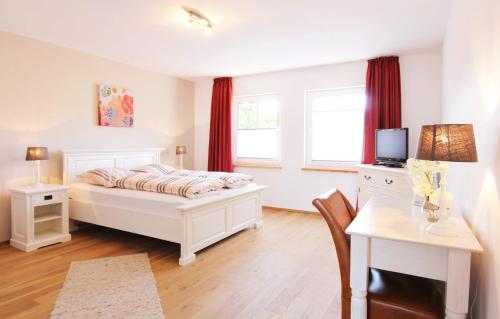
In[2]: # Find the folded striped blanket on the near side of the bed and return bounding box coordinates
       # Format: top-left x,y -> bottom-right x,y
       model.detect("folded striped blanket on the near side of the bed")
116,173 -> 224,198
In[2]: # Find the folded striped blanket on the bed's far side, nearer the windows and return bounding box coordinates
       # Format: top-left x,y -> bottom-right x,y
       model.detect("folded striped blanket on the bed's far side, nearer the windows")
132,164 -> 253,188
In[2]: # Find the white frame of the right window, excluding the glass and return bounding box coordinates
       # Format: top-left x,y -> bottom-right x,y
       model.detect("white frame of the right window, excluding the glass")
303,85 -> 365,171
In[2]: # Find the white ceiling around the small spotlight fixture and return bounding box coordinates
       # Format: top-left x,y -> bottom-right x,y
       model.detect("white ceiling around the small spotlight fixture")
0,0 -> 451,78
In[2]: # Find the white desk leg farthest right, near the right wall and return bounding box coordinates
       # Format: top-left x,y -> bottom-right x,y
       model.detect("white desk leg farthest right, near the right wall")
446,249 -> 471,319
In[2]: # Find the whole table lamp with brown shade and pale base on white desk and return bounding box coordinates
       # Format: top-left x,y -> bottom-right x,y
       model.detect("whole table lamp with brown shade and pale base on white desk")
416,124 -> 477,236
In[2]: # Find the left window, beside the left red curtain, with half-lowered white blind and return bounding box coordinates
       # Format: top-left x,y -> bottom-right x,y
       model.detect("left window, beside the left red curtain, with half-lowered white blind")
233,95 -> 280,162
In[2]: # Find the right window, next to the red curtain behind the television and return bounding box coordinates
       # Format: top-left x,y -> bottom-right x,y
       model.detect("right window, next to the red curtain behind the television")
306,87 -> 366,166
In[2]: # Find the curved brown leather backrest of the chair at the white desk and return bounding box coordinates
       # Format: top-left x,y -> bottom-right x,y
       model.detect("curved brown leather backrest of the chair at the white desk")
313,189 -> 356,319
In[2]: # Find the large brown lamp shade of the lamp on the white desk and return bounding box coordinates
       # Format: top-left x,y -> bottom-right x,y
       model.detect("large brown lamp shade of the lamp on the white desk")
416,124 -> 477,162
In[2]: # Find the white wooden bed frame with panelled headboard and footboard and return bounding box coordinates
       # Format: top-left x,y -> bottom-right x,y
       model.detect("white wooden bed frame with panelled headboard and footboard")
62,148 -> 266,266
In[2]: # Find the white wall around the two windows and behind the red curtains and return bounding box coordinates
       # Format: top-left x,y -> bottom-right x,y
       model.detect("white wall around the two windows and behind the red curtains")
195,50 -> 441,210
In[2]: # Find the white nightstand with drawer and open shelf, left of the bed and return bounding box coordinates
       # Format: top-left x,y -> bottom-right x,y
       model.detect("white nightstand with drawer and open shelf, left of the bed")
10,184 -> 71,251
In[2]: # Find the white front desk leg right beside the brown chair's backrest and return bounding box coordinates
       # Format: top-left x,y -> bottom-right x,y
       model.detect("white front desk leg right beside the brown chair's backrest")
350,235 -> 370,319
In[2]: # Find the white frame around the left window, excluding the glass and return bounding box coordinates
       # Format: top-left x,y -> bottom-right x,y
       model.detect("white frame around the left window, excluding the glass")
231,93 -> 283,168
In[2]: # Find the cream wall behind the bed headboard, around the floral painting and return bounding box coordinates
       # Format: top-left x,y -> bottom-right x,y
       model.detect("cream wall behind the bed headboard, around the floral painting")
0,32 -> 194,241
